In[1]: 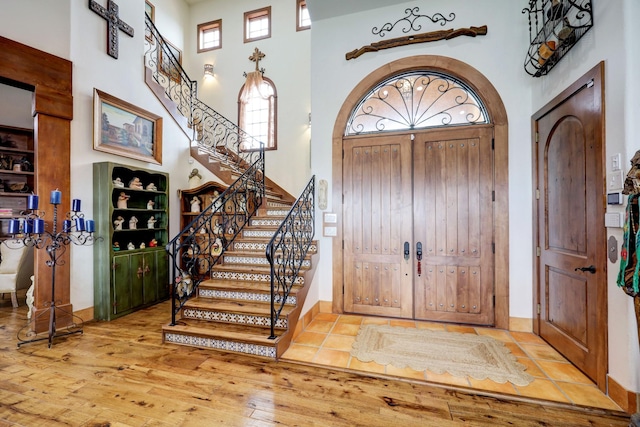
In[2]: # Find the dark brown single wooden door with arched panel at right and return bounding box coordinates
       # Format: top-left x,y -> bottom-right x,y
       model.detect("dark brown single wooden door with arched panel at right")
534,61 -> 607,388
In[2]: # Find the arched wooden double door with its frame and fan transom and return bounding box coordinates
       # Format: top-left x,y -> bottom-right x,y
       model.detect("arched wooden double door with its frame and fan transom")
333,56 -> 508,328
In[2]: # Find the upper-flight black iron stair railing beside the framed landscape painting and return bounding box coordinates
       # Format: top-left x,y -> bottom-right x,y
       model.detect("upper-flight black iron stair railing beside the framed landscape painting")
145,14 -> 262,174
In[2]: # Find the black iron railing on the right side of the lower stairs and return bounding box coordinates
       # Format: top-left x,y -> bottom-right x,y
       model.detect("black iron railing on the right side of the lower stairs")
266,175 -> 316,339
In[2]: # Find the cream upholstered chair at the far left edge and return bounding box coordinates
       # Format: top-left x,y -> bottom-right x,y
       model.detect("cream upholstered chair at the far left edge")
0,244 -> 33,307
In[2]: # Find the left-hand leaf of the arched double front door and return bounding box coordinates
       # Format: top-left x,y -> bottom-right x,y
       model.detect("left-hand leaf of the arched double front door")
343,136 -> 413,318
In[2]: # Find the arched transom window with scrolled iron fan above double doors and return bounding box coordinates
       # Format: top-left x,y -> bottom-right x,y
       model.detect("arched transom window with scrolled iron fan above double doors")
345,71 -> 489,135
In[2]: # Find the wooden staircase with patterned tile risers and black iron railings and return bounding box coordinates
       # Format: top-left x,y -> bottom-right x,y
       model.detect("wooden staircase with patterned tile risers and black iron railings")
145,16 -> 318,359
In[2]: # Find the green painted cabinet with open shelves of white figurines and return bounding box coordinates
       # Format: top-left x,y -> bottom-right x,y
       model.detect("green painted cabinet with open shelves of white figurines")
93,162 -> 170,320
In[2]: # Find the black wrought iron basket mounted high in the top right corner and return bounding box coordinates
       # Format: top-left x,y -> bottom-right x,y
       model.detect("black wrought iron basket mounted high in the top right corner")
522,0 -> 593,77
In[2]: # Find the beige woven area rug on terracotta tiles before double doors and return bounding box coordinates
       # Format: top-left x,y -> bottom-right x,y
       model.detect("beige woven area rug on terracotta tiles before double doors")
351,325 -> 533,386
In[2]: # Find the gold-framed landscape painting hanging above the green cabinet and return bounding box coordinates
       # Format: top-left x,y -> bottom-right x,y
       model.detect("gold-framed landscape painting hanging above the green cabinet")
93,88 -> 162,165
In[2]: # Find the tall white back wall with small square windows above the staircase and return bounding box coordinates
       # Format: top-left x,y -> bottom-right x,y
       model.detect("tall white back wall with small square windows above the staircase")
185,0 -> 311,197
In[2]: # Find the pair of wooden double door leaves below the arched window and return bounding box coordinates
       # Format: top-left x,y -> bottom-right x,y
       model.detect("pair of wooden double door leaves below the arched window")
343,126 -> 494,325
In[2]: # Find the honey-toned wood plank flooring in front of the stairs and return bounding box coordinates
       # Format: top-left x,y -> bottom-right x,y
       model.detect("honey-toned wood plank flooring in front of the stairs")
0,299 -> 629,427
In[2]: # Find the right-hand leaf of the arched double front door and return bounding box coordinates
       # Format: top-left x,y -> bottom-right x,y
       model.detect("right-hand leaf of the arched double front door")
414,127 -> 494,325
